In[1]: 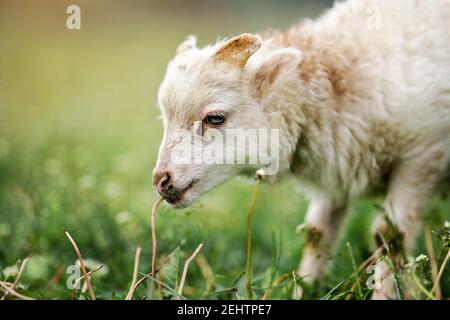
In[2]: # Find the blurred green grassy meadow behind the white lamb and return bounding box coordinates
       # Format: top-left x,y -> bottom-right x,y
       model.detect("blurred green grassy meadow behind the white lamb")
0,0 -> 450,299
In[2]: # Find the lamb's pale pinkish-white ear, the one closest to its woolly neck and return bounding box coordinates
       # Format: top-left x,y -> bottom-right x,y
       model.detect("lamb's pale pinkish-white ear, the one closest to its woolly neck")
254,48 -> 301,91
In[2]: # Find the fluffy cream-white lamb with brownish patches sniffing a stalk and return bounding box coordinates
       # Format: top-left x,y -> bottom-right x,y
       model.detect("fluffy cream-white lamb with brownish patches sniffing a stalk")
154,0 -> 450,299
